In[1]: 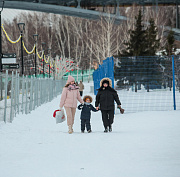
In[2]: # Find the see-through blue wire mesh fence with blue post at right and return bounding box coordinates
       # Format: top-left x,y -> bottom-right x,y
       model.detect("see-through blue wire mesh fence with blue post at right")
114,56 -> 180,112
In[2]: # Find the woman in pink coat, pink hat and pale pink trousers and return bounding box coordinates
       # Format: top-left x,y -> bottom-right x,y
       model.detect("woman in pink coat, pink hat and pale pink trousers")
60,76 -> 84,133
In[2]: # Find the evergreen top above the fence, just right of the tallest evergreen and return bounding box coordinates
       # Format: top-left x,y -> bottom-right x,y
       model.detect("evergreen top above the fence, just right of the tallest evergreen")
146,19 -> 160,56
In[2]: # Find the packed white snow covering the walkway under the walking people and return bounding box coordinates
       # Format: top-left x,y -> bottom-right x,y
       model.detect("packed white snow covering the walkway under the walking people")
0,84 -> 180,177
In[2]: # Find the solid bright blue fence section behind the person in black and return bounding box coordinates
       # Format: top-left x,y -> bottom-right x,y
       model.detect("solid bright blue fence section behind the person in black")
93,57 -> 114,95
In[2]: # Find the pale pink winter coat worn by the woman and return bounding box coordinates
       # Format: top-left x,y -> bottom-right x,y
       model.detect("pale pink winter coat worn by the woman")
60,87 -> 84,108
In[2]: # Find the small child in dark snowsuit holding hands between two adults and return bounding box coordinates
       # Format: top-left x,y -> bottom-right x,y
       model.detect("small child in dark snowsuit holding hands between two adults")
78,95 -> 97,133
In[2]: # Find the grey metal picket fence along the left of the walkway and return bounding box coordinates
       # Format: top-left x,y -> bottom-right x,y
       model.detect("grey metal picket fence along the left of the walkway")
0,71 -> 65,122
